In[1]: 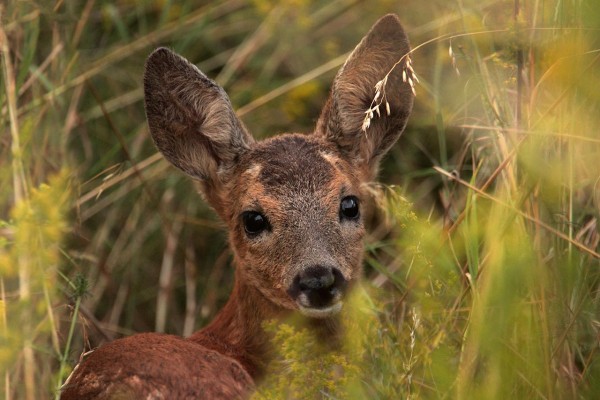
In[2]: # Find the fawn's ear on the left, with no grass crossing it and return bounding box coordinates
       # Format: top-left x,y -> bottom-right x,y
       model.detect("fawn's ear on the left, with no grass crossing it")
144,48 -> 254,186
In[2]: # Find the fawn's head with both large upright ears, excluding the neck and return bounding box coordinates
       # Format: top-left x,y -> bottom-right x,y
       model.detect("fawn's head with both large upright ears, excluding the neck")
144,15 -> 413,318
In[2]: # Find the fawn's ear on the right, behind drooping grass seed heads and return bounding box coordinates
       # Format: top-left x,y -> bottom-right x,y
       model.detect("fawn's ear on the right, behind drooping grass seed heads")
315,14 -> 414,179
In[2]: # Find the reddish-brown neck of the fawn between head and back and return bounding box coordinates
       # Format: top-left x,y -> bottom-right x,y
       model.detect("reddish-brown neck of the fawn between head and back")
189,273 -> 285,380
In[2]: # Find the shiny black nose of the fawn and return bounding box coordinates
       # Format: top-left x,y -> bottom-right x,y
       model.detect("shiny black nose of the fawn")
288,265 -> 346,308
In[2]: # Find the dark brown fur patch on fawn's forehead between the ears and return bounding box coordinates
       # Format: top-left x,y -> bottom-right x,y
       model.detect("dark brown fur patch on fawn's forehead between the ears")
247,134 -> 334,192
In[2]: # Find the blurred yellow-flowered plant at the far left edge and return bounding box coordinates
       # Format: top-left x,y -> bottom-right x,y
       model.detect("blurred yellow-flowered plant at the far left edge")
0,170 -> 70,394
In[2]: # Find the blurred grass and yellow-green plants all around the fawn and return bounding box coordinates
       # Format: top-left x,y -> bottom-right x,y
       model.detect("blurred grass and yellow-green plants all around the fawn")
0,0 -> 600,399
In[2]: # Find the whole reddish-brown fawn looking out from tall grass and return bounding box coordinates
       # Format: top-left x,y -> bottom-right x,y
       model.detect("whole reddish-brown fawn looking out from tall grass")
62,15 -> 413,400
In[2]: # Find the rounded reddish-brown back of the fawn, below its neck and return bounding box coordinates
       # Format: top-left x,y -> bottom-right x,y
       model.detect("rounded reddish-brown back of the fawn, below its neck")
61,333 -> 253,400
